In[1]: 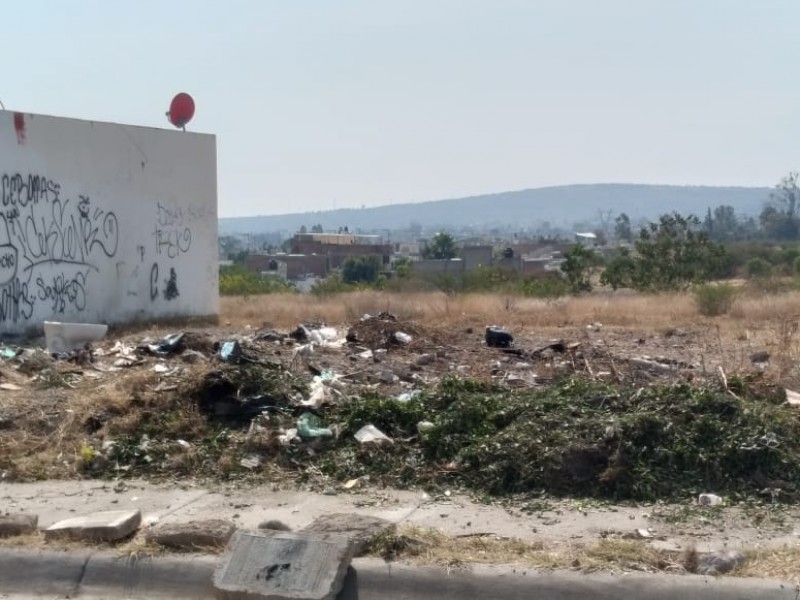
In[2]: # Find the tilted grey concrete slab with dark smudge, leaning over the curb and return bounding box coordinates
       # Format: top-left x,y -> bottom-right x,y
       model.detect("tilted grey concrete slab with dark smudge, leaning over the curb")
214,531 -> 354,600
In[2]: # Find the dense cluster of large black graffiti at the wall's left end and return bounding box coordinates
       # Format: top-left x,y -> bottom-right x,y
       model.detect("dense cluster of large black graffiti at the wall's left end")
0,173 -> 119,323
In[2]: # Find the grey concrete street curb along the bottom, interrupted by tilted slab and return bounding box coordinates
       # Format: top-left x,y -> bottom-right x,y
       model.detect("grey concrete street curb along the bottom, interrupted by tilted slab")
0,549 -> 798,600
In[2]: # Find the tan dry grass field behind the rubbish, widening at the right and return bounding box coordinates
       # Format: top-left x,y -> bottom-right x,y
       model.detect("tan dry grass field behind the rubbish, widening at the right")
220,290 -> 800,387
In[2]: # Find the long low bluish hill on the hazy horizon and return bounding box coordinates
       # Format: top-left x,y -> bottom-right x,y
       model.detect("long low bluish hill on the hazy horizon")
219,184 -> 771,235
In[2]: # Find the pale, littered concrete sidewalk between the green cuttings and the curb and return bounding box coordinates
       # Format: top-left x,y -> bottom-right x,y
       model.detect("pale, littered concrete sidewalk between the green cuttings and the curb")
0,480 -> 798,552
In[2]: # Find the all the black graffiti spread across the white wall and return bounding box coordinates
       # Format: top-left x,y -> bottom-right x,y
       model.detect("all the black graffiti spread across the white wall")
0,173 -> 200,324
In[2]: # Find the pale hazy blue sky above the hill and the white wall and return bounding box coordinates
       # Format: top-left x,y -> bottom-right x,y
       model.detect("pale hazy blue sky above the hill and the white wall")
6,0 -> 800,216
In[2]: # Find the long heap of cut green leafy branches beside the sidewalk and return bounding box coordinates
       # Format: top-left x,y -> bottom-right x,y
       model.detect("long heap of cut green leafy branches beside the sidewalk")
310,377 -> 800,501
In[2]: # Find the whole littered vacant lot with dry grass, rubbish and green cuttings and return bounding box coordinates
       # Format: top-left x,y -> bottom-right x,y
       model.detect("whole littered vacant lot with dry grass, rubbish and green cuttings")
0,293 -> 800,580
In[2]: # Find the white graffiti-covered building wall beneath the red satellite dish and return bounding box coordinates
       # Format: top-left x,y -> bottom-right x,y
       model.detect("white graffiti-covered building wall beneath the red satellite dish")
0,111 -> 219,333
